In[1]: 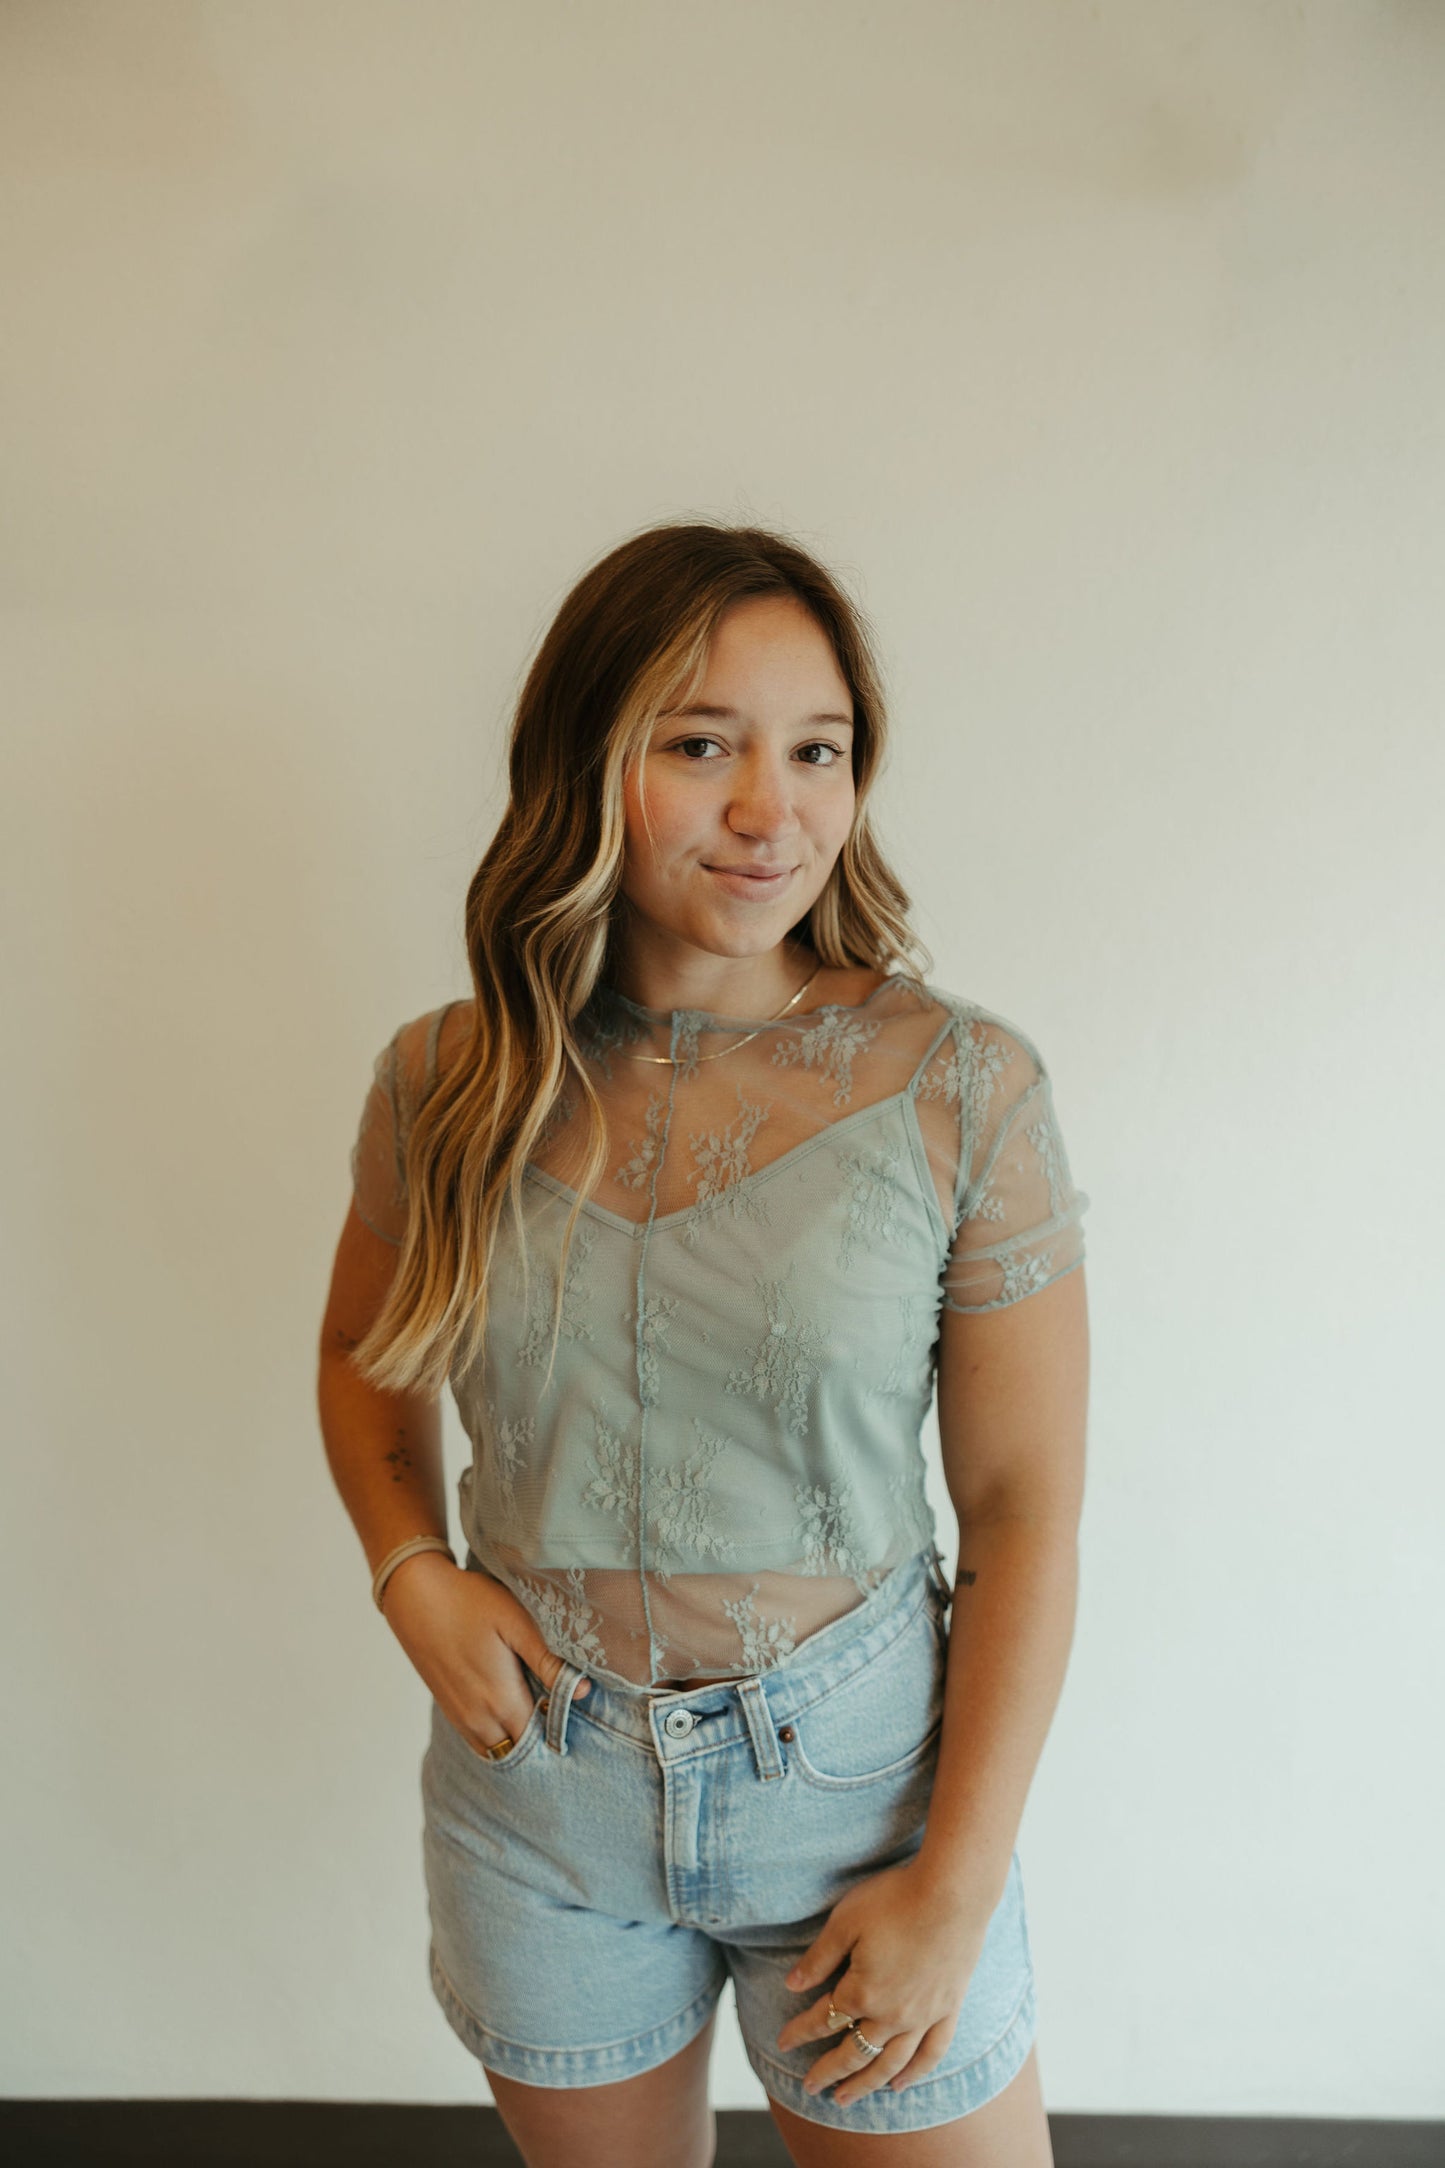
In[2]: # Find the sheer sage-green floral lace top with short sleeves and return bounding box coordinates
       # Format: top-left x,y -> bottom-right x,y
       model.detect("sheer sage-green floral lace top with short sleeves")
351,973 -> 1090,1689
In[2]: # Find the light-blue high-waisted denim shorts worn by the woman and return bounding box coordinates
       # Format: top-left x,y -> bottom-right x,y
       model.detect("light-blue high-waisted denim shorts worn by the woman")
422,1550 -> 1036,2133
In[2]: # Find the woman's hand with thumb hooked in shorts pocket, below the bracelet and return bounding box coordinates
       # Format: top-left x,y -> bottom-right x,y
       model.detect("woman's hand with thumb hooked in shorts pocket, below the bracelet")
381,1550 -> 589,1752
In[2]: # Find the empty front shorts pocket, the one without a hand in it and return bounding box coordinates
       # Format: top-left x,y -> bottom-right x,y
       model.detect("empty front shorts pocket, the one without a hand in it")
786,1602 -> 945,1791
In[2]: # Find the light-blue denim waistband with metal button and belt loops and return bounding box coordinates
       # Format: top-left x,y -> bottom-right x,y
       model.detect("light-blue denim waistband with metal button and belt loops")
530,1546 -> 951,1776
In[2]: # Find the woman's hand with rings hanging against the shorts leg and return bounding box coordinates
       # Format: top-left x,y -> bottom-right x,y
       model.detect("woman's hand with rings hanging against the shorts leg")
778,1858 -> 988,2105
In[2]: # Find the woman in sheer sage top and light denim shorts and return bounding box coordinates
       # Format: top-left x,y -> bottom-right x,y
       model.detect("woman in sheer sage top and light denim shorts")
321,522 -> 1088,2168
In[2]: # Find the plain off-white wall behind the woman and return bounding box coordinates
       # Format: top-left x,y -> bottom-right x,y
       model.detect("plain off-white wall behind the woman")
0,0 -> 1445,2116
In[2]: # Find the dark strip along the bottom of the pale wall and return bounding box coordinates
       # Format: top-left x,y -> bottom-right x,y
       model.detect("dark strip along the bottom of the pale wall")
0,2101 -> 1445,2168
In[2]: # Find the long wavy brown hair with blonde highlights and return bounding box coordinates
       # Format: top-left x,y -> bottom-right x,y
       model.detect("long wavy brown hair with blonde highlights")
351,520 -> 932,1392
